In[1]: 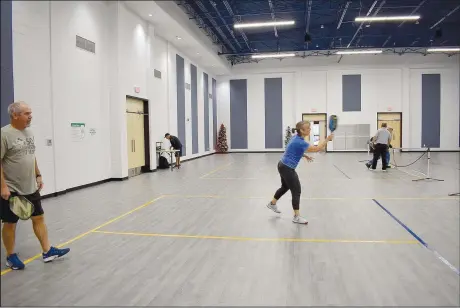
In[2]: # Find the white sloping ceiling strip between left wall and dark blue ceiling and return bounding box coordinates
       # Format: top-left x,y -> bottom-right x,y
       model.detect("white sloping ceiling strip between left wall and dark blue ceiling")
124,1 -> 230,76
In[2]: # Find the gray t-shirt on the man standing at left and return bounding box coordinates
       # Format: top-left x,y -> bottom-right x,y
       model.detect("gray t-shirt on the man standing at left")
1,125 -> 38,195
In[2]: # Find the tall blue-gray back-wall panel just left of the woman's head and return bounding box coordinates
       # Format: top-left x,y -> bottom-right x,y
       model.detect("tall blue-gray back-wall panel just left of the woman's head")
265,78 -> 283,149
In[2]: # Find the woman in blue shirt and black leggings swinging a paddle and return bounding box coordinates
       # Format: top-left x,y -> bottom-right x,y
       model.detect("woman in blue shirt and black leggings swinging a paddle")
267,121 -> 333,224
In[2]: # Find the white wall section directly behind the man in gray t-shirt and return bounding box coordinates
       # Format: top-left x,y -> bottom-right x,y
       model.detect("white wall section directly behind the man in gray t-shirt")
12,1 -> 56,194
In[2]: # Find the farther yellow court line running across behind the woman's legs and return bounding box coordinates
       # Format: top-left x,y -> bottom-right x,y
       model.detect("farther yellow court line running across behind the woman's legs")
164,194 -> 460,200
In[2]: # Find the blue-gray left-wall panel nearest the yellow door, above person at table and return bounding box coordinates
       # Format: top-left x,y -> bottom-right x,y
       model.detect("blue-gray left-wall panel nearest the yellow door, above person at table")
176,55 -> 187,156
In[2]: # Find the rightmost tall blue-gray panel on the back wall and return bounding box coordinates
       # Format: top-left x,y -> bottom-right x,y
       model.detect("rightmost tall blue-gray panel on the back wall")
421,74 -> 441,148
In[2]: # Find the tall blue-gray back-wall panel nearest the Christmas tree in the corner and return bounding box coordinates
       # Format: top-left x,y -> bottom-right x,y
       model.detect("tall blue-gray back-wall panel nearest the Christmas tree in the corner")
230,79 -> 248,149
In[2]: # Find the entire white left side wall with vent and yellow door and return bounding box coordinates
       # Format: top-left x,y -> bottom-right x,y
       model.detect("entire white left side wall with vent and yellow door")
13,1 -> 217,194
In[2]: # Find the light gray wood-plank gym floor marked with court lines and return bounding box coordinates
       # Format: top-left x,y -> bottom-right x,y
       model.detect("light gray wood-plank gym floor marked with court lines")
1,153 -> 460,306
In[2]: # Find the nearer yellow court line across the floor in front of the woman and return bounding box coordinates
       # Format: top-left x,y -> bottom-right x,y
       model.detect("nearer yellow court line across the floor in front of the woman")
93,231 -> 418,244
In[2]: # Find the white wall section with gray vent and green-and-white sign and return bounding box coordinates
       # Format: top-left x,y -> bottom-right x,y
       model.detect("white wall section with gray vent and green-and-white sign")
51,1 -> 110,191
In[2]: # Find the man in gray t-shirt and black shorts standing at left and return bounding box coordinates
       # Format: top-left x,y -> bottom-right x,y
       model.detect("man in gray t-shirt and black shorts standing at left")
0,102 -> 70,270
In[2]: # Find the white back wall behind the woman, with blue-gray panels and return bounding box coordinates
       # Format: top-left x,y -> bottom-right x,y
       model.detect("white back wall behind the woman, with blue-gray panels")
218,55 -> 459,151
